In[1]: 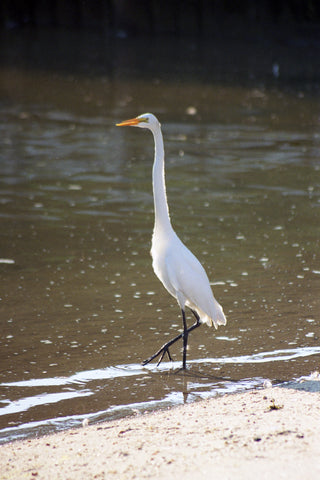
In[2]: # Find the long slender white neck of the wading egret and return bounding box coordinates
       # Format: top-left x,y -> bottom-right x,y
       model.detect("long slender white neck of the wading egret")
152,128 -> 171,230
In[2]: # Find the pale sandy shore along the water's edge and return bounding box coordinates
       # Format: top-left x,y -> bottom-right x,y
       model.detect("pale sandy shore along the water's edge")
0,382 -> 320,480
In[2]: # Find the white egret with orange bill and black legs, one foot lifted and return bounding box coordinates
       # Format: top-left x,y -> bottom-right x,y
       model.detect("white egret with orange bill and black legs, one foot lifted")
116,113 -> 227,370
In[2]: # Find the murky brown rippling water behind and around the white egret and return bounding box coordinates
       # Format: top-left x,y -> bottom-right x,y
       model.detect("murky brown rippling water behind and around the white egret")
0,32 -> 320,442
